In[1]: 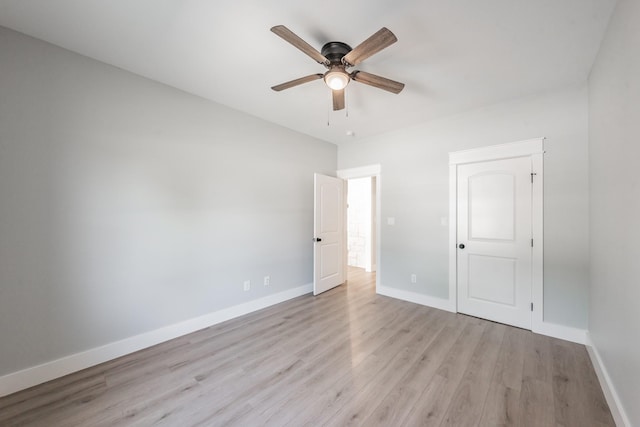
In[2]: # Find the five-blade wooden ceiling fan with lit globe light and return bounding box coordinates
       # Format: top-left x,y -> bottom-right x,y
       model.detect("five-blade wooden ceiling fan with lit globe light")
271,25 -> 404,111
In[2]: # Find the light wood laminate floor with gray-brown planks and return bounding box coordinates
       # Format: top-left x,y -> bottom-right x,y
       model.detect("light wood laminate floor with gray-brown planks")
0,269 -> 614,427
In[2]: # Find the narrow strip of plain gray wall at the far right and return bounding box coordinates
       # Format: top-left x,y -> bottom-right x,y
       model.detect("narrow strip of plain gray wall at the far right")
589,0 -> 640,426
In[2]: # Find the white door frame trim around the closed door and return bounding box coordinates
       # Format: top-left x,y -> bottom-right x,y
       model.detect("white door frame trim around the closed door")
449,138 -> 544,332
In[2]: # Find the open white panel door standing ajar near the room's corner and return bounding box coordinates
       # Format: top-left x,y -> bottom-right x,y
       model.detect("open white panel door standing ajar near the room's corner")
313,174 -> 345,295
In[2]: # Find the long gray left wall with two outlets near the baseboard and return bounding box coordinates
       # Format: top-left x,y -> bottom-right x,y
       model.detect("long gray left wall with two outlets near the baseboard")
0,27 -> 336,376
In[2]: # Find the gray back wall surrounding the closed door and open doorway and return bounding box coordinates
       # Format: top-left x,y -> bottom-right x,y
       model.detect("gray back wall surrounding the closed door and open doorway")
338,87 -> 589,328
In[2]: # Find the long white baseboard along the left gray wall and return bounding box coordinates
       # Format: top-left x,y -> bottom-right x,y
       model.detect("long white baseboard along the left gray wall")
0,284 -> 313,397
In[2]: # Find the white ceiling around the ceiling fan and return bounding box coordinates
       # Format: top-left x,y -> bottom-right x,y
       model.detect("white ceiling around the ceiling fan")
0,0 -> 616,144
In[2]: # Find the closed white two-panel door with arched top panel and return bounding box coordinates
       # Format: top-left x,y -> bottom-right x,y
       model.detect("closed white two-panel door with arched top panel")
457,157 -> 532,329
